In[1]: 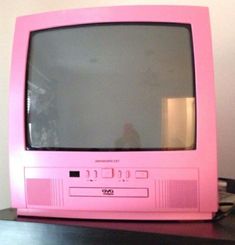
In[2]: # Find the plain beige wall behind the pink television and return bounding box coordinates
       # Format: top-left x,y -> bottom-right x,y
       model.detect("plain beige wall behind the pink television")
0,0 -> 235,209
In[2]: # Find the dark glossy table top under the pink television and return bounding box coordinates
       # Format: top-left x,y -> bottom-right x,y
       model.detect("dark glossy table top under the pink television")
0,209 -> 235,245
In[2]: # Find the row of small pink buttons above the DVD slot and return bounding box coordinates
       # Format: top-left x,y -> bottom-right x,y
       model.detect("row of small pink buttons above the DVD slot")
86,168 -> 148,179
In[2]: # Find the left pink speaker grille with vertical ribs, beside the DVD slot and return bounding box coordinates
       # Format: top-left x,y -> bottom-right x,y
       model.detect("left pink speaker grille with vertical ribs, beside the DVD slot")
26,179 -> 64,207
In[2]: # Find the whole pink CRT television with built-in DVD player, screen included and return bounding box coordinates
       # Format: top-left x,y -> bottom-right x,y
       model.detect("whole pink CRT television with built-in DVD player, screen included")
9,6 -> 217,220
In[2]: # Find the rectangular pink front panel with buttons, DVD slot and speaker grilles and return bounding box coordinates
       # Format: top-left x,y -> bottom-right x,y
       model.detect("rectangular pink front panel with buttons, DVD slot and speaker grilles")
25,166 -> 199,211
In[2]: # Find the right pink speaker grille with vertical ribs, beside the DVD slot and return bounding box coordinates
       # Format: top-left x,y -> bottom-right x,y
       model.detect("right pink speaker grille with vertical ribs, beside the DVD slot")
156,180 -> 198,209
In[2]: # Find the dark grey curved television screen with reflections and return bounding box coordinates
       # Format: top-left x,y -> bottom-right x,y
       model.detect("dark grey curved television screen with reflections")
26,23 -> 196,151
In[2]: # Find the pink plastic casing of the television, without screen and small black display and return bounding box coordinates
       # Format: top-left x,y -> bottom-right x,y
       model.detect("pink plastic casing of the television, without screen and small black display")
9,6 -> 217,220
